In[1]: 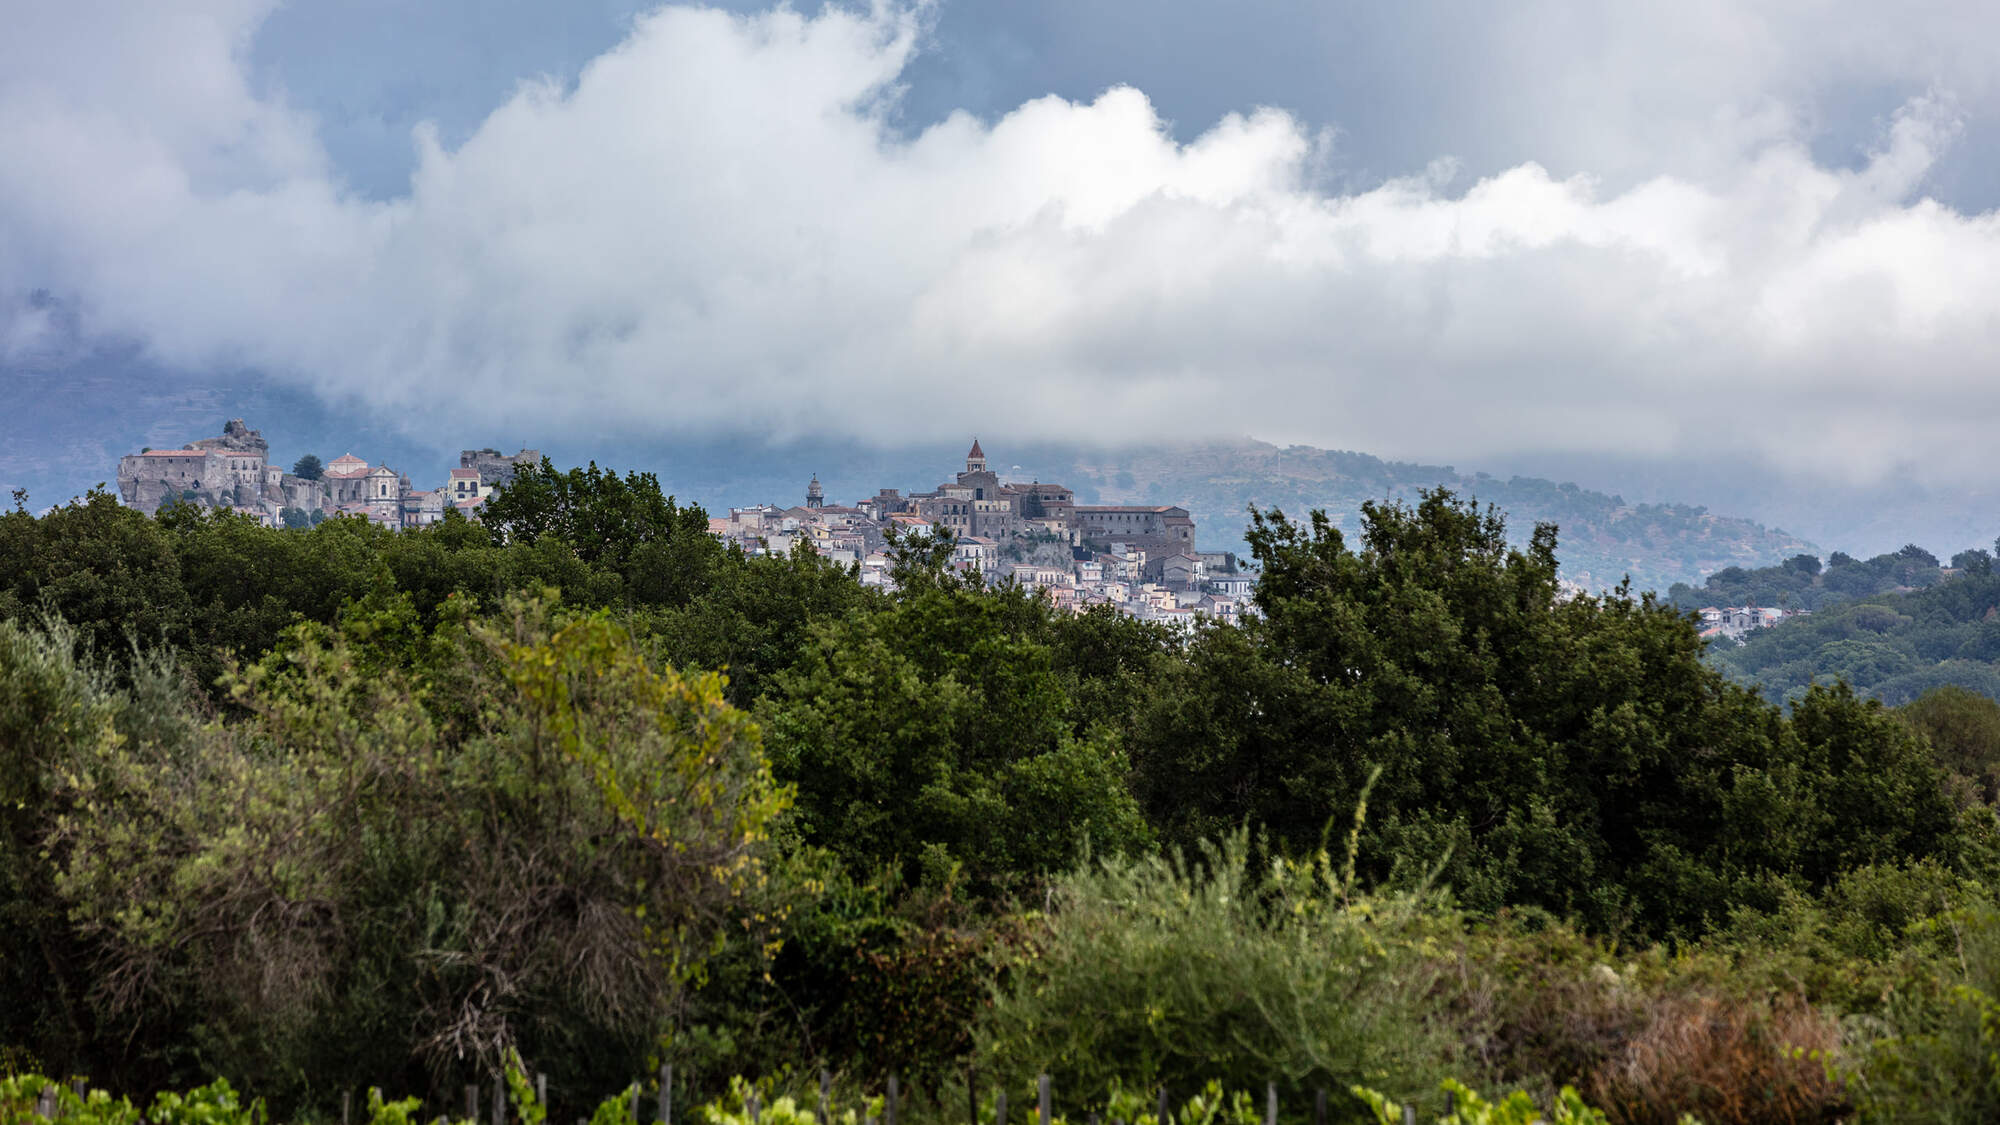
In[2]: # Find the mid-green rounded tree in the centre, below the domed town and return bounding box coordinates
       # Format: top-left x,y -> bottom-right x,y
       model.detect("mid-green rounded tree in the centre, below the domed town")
760,572 -> 1146,889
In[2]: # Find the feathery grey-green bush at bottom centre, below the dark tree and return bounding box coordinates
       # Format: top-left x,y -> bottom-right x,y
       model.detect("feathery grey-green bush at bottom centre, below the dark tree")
980,833 -> 1458,1103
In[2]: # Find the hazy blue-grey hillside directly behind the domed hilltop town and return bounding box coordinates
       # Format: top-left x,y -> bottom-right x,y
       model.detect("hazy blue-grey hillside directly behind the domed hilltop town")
1036,440 -> 1812,591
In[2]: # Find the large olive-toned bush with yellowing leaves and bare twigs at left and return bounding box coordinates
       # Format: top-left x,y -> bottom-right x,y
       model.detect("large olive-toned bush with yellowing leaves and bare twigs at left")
23,601 -> 788,1097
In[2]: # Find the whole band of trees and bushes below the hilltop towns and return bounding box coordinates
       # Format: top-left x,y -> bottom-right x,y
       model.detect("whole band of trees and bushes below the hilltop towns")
0,466 -> 2000,1123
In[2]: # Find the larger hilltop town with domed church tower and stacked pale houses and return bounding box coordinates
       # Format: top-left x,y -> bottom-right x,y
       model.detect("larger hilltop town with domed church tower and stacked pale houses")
708,438 -> 1254,623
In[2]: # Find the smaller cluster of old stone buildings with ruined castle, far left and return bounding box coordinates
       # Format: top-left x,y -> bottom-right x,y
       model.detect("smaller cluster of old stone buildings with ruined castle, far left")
118,418 -> 542,528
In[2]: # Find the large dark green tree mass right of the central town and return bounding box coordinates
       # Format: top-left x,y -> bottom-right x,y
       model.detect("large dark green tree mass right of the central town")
1132,490 -> 1956,935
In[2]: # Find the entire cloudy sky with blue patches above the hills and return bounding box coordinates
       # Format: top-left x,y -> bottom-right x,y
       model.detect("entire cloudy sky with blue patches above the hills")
0,0 -> 2000,524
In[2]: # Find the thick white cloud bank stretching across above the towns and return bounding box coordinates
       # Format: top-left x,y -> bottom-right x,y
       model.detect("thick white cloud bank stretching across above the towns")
0,0 -> 2000,476
